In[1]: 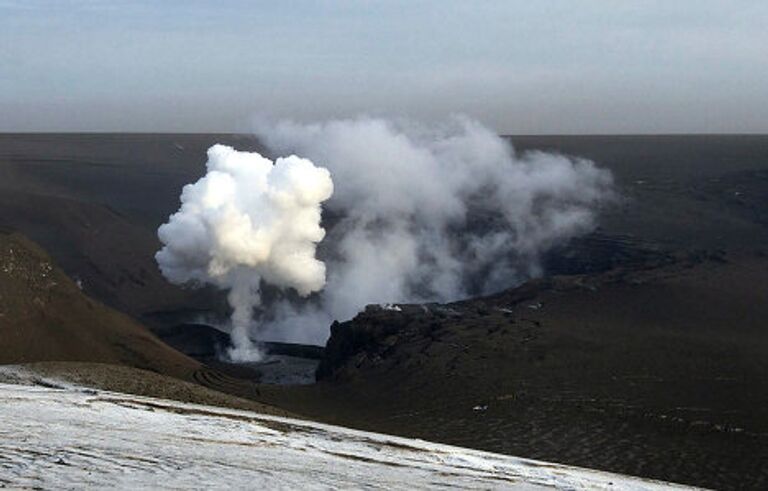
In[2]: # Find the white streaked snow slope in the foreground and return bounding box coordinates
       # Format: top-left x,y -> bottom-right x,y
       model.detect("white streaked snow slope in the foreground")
0,376 -> 692,489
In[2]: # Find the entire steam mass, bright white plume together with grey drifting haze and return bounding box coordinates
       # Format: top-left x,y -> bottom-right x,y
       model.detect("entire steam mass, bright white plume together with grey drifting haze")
157,118 -> 613,359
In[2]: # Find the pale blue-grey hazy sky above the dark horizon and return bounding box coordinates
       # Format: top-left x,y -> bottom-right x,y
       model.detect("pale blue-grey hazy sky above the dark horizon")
0,0 -> 768,134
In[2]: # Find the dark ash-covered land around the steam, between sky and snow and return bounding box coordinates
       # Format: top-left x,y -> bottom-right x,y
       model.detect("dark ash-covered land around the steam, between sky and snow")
0,134 -> 768,489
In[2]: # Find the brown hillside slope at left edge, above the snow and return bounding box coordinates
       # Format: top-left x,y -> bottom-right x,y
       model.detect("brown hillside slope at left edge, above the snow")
0,233 -> 199,378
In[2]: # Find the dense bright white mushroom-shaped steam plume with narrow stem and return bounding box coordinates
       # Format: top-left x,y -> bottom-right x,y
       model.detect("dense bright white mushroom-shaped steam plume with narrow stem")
156,145 -> 333,361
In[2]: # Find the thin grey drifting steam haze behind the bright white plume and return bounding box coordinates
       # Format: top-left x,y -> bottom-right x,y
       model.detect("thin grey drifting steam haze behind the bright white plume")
257,118 -> 613,343
